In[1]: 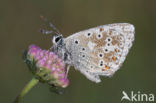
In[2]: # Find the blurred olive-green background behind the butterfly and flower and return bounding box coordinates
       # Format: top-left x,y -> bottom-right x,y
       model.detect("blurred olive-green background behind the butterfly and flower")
0,0 -> 156,103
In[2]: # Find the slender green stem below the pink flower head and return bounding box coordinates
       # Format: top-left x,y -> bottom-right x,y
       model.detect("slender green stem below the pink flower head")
13,77 -> 39,103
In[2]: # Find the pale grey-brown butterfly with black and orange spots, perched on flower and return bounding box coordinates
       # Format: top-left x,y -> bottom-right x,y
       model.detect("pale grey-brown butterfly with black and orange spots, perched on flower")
41,16 -> 135,83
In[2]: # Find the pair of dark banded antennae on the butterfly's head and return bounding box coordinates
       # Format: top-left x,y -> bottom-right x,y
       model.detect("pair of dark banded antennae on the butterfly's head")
40,16 -> 61,35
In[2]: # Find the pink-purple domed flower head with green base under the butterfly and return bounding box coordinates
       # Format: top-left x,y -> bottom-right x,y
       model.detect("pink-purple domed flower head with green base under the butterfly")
25,45 -> 69,88
